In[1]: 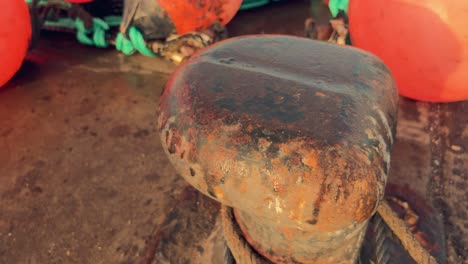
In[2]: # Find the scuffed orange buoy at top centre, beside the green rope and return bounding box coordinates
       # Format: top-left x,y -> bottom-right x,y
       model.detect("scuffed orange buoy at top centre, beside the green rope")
159,0 -> 242,34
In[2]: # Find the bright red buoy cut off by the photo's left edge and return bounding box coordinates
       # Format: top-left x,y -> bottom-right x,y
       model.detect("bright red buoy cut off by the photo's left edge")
0,0 -> 31,87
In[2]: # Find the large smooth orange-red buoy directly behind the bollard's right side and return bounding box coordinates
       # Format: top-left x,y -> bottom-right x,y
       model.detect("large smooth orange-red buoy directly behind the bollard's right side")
348,0 -> 468,102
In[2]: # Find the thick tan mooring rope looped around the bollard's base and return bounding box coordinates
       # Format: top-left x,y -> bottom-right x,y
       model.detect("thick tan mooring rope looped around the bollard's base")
221,201 -> 437,264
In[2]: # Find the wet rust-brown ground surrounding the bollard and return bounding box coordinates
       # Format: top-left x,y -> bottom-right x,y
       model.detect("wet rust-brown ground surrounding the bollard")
0,1 -> 468,264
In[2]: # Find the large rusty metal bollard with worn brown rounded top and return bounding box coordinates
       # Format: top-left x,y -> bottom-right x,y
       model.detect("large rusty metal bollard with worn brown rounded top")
159,35 -> 398,263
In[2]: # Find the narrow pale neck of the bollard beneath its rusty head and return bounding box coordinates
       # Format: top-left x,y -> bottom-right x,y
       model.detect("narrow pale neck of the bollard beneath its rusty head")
233,209 -> 368,264
